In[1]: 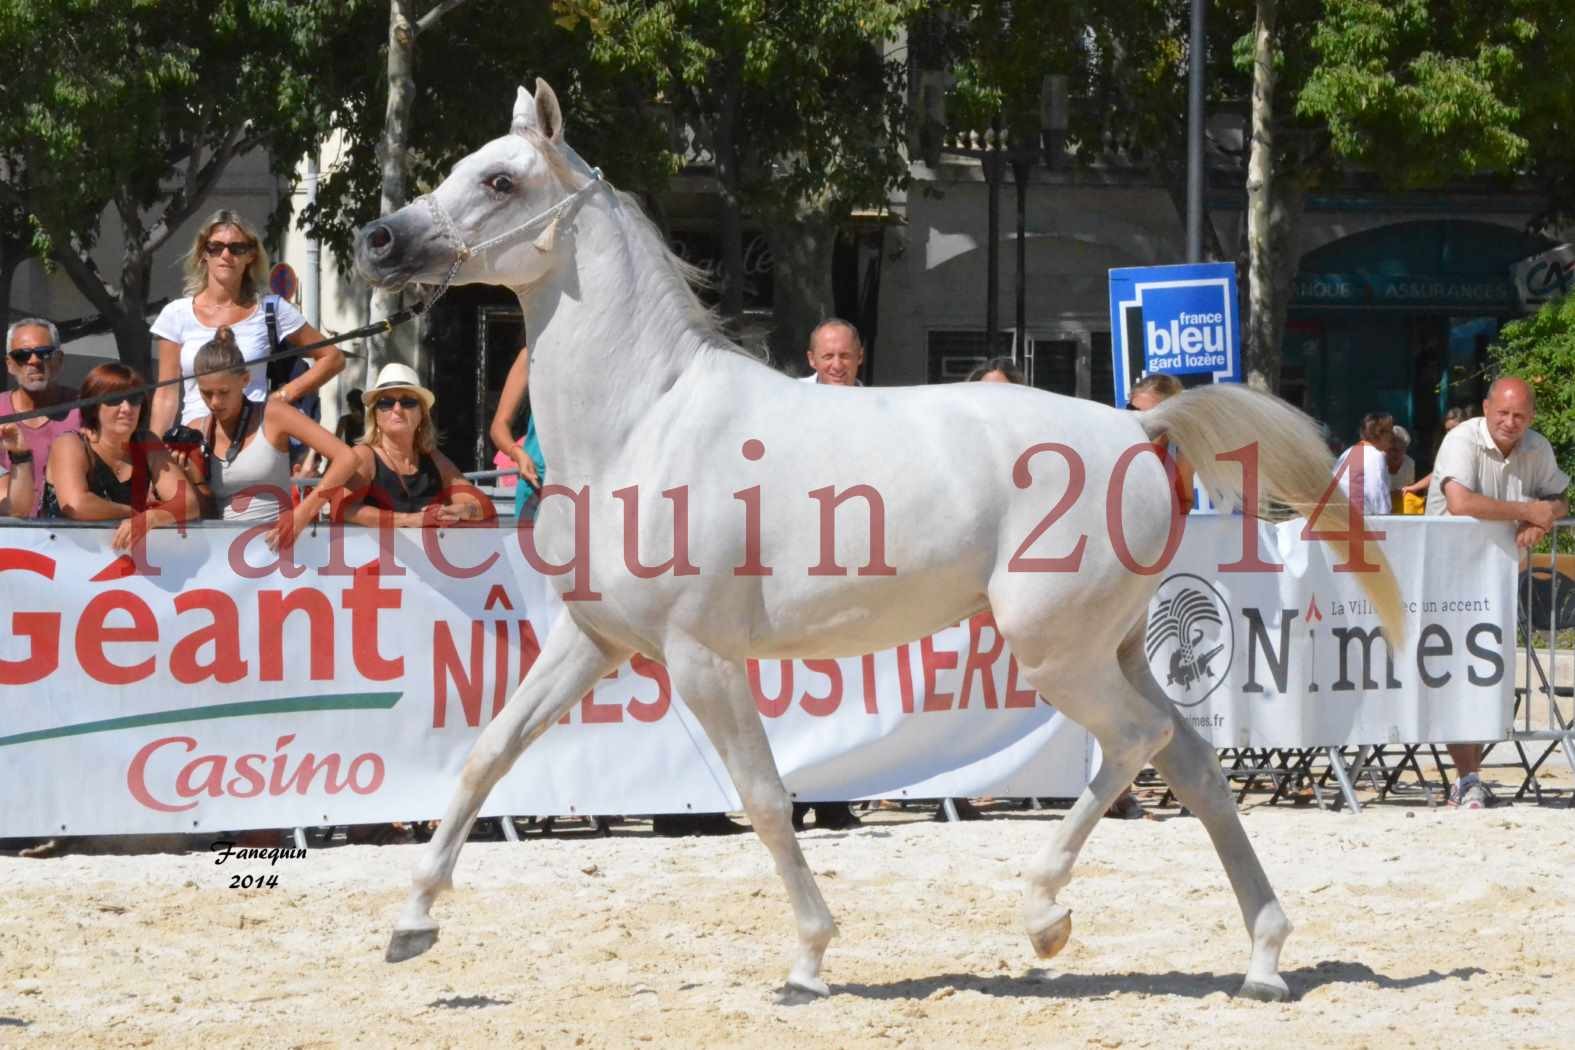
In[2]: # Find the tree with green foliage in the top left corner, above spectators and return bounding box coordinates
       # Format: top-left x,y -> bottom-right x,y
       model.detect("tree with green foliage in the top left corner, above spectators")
0,0 -> 367,365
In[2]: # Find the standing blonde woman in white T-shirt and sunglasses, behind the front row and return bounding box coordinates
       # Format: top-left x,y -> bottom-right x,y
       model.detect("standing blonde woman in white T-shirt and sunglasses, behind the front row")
153,209 -> 345,434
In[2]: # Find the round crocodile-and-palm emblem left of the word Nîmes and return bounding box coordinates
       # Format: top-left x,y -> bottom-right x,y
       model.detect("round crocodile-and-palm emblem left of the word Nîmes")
1143,573 -> 1236,707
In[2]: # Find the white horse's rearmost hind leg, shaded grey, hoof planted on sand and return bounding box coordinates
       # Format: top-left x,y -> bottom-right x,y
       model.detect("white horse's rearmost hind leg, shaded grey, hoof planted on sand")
1121,653 -> 1292,1003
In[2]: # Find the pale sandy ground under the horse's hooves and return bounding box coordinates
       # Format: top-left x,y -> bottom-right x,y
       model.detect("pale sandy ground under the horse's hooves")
0,783 -> 1575,1048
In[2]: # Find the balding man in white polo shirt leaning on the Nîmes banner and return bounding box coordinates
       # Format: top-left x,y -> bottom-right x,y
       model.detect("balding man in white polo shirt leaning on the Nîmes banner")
1427,378 -> 1570,809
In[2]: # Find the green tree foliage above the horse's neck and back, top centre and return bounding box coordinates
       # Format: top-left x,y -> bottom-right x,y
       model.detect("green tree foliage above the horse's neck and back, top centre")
554,0 -> 925,329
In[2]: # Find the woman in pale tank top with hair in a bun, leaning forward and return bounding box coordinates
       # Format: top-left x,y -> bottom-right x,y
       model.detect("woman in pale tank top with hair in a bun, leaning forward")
175,326 -> 356,549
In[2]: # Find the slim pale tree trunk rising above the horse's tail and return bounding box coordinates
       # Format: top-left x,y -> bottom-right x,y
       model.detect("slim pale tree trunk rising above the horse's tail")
1243,0 -> 1285,392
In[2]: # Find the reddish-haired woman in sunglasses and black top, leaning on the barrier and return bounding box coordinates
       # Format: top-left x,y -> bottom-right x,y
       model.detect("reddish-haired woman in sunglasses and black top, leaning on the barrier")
44,362 -> 198,551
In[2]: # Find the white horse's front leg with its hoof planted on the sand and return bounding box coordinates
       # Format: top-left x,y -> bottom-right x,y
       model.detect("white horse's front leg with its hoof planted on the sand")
665,642 -> 836,996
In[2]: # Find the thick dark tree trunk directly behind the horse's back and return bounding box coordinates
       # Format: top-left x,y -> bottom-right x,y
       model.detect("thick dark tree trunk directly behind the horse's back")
765,205 -> 836,368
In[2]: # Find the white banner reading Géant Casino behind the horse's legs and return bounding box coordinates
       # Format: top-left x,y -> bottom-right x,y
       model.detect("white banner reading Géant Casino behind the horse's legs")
0,526 -> 1091,836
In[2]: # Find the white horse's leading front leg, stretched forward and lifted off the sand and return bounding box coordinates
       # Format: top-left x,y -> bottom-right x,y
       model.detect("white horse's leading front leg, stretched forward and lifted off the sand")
386,612 -> 628,962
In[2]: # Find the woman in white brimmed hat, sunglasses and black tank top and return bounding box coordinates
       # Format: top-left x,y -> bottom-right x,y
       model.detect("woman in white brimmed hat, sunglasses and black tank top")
345,364 -> 491,527
